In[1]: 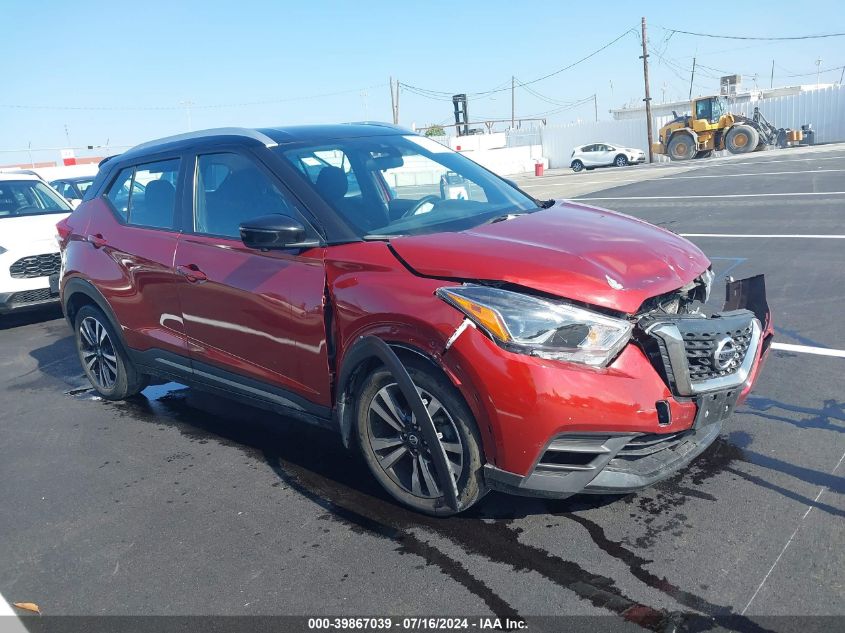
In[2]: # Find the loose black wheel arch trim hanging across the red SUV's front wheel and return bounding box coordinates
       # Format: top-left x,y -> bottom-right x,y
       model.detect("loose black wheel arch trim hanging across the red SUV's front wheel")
335,335 -> 460,512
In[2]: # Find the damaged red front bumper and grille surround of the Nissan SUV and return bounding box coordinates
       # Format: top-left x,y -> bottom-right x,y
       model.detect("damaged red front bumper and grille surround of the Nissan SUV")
448,277 -> 772,498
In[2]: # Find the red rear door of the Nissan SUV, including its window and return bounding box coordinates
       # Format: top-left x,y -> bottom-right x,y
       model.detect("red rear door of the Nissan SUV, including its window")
94,156 -> 187,357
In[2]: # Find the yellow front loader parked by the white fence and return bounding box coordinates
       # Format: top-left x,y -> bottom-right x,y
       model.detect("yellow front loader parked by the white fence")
651,96 -> 802,160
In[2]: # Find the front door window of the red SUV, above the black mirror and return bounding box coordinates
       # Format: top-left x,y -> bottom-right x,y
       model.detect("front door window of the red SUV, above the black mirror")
194,153 -> 299,239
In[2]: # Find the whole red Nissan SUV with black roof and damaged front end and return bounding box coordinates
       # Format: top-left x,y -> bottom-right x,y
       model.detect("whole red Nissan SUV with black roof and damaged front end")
58,124 -> 772,515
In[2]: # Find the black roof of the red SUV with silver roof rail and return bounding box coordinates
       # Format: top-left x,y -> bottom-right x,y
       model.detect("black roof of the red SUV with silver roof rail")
116,122 -> 412,165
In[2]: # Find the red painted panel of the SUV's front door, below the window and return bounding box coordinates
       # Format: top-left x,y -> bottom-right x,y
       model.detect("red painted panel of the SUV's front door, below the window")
175,235 -> 331,406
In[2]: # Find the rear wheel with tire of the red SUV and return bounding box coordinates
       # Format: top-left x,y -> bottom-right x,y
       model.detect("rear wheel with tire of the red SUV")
74,305 -> 149,400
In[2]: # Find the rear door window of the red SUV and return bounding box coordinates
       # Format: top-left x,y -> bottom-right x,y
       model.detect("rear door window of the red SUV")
106,158 -> 179,229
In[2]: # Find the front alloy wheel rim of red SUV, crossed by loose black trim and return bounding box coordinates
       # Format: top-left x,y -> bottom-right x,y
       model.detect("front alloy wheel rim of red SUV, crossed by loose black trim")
367,383 -> 464,499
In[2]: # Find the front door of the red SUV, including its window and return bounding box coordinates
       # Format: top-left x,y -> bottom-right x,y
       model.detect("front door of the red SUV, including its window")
175,149 -> 331,415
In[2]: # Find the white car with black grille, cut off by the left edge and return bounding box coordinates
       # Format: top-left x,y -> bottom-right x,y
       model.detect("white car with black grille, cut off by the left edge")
0,173 -> 71,314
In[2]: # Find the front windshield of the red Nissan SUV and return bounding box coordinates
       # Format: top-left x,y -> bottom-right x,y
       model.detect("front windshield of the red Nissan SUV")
278,135 -> 537,239
